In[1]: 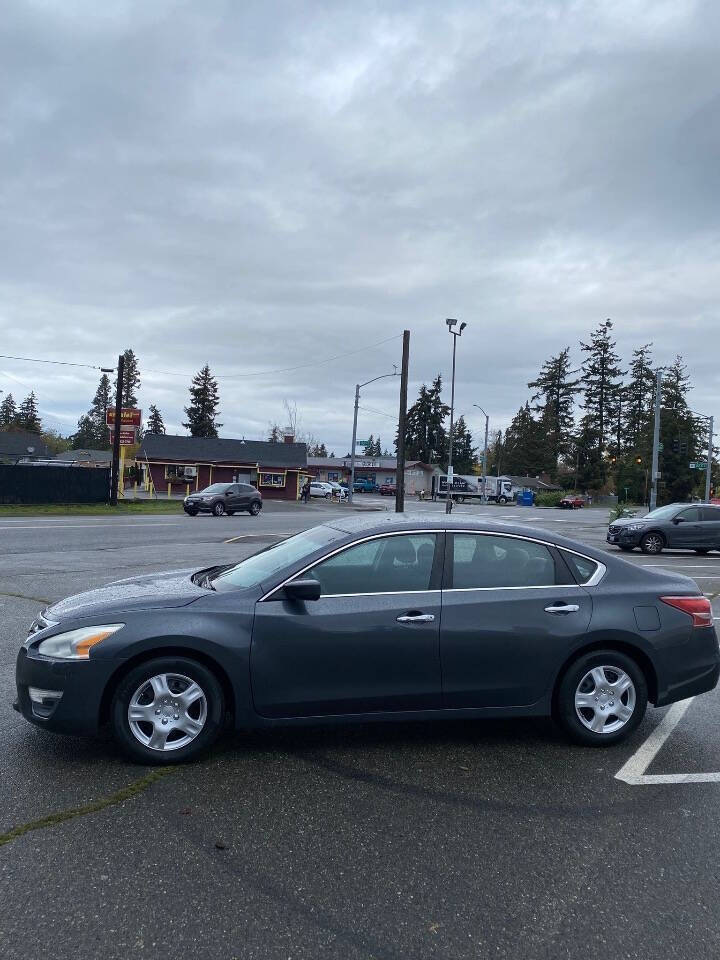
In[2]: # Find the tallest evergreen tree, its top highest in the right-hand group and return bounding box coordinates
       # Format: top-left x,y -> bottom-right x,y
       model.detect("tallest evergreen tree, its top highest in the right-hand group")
578,320 -> 623,489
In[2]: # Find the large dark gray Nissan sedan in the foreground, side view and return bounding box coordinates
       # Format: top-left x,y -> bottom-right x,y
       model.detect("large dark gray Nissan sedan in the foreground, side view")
16,515 -> 720,763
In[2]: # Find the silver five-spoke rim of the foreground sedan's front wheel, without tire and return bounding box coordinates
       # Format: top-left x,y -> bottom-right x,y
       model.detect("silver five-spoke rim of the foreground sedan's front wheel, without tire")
128,673 -> 208,752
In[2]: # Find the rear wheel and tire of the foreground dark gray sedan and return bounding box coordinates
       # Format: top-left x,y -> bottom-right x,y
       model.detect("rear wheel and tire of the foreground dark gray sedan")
555,650 -> 648,747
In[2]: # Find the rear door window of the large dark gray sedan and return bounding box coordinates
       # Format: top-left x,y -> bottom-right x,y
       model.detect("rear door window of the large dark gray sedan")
452,533 -> 556,590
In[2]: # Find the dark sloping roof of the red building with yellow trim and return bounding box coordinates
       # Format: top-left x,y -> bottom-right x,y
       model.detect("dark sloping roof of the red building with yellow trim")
137,433 -> 307,469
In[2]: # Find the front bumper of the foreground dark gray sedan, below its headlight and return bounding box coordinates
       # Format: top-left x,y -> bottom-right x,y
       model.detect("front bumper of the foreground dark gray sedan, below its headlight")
13,647 -> 117,736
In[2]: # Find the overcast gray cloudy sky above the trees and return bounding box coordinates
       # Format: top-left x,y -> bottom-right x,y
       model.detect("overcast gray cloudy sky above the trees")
0,0 -> 720,454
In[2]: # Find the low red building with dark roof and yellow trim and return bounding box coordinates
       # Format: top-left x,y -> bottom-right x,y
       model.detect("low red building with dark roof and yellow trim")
137,433 -> 307,500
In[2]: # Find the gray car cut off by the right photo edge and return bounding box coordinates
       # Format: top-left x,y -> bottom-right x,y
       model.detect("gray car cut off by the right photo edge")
607,503 -> 720,554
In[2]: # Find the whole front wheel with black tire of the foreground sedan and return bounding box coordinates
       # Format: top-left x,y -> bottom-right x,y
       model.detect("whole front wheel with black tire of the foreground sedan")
110,657 -> 225,766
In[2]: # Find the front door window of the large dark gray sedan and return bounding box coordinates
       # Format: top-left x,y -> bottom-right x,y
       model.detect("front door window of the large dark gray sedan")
303,533 -> 437,596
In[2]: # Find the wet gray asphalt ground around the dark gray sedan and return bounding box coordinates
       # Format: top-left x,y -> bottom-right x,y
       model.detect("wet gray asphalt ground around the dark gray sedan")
0,497 -> 720,960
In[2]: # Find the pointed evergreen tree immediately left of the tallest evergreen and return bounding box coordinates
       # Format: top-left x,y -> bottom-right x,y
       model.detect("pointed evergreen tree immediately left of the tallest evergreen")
528,347 -> 580,476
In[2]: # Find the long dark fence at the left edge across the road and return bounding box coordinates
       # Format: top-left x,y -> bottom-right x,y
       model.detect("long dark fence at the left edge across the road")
0,464 -> 110,503
